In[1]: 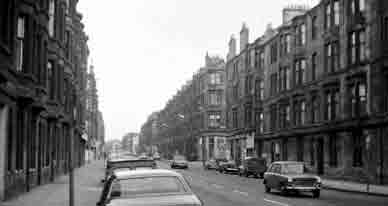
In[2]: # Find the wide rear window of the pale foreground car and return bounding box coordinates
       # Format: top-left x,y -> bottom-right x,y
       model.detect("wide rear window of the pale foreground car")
111,177 -> 187,198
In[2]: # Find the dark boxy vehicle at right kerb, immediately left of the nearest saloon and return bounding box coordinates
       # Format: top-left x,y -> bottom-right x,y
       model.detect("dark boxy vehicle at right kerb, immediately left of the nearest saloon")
239,157 -> 267,178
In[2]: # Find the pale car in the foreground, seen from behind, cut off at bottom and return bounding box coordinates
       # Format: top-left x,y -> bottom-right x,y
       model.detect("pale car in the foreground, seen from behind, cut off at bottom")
97,169 -> 203,206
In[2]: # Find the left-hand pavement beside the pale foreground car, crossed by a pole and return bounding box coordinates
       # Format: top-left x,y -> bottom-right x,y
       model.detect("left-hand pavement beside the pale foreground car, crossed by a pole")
0,160 -> 104,206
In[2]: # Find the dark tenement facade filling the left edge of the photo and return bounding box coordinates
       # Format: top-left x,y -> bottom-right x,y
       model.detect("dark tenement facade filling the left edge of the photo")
0,0 -> 92,200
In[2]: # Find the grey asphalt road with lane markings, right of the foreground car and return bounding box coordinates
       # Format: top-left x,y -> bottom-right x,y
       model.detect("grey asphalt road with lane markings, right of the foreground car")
159,162 -> 388,206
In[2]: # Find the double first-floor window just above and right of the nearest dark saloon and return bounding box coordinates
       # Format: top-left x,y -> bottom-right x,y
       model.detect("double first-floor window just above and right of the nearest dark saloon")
325,90 -> 340,120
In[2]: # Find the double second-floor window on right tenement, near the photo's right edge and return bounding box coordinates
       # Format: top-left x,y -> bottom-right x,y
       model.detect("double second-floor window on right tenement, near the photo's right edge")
349,30 -> 366,64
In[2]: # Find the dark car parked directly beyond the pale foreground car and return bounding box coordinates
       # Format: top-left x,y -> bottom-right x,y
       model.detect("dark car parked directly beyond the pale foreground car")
102,158 -> 157,182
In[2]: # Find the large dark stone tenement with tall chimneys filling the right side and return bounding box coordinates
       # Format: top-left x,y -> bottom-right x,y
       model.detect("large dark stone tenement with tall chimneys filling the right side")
226,0 -> 388,184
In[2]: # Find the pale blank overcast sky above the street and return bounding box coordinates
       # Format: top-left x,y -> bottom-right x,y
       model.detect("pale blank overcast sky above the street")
78,0 -> 318,140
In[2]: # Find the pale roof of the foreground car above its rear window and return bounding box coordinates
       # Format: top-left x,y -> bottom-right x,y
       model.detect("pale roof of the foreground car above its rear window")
115,169 -> 182,179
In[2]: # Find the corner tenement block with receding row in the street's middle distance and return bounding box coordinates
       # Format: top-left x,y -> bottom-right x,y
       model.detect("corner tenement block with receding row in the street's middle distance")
149,55 -> 227,160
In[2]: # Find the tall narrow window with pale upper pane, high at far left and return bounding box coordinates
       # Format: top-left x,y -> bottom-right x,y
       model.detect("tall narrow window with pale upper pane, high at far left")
16,16 -> 26,72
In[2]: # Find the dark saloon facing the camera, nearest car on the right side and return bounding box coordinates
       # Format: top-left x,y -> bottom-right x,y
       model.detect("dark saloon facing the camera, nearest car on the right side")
263,161 -> 322,198
